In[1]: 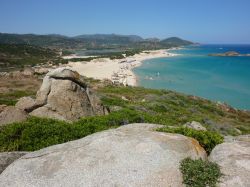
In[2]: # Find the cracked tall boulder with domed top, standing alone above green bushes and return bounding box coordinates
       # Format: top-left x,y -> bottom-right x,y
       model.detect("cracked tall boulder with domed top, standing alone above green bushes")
30,67 -> 107,121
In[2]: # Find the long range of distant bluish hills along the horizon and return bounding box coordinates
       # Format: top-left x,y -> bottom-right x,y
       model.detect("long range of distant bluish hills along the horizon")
0,33 -> 192,49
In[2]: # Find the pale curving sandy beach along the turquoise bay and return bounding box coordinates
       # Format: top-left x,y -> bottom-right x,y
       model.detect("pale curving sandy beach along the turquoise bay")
64,50 -> 176,86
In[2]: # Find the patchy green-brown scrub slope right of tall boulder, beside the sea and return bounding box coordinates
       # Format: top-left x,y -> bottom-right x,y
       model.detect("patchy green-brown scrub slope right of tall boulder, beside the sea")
96,86 -> 250,135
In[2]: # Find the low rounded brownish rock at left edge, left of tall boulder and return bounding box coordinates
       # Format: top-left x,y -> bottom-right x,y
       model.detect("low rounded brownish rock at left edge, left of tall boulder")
0,106 -> 28,126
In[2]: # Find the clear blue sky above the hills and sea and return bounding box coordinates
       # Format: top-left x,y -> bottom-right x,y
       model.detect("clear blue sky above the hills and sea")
0,0 -> 250,44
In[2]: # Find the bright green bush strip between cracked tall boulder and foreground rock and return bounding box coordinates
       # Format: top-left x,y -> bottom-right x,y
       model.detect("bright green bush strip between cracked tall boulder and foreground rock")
0,110 -> 146,152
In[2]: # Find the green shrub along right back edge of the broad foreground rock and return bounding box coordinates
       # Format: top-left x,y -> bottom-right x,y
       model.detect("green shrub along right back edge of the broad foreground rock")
158,127 -> 223,154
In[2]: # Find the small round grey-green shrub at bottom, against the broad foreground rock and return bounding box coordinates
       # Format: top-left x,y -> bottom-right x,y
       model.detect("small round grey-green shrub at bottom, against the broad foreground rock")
180,158 -> 222,187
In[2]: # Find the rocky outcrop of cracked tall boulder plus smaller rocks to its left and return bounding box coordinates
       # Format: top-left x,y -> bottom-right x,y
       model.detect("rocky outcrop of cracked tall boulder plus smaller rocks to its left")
0,67 -> 106,125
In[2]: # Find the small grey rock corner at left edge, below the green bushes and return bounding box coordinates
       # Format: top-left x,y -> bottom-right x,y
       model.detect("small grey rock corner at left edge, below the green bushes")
0,152 -> 28,174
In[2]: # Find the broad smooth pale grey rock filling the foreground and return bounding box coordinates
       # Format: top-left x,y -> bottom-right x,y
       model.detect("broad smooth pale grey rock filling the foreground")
0,124 -> 206,187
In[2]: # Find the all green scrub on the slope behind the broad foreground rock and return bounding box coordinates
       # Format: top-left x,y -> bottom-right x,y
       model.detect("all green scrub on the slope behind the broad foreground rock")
0,83 -> 250,153
